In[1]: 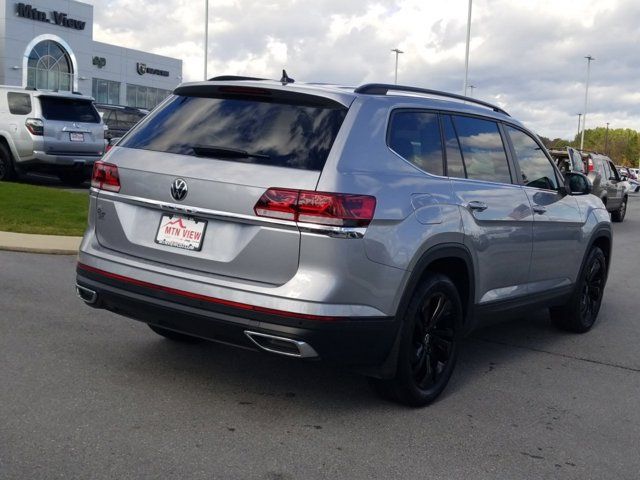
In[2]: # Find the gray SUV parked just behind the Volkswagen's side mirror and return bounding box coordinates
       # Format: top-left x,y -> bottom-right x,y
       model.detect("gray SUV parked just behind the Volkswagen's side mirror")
549,147 -> 629,222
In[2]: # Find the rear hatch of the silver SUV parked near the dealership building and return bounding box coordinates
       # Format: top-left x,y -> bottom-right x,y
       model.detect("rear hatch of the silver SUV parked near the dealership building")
38,95 -> 105,156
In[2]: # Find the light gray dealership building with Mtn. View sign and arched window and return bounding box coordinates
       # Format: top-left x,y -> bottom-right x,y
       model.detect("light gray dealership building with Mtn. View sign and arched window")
0,0 -> 182,108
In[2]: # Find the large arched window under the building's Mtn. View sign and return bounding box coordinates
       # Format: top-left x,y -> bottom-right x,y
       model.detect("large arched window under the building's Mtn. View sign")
27,40 -> 73,90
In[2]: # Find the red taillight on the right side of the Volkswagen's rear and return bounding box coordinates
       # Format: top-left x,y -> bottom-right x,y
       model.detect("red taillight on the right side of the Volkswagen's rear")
253,188 -> 376,227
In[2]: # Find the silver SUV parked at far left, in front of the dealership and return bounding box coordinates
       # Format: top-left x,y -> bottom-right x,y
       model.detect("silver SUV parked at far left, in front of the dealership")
0,86 -> 106,184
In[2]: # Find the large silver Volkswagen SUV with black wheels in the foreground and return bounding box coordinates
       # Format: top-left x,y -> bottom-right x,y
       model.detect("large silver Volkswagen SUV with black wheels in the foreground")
77,77 -> 612,405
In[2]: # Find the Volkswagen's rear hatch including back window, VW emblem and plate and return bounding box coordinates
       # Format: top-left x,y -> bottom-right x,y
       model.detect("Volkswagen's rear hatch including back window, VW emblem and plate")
96,84 -> 347,285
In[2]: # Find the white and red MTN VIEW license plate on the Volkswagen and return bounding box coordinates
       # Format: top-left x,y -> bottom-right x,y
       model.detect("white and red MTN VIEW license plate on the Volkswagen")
155,213 -> 208,252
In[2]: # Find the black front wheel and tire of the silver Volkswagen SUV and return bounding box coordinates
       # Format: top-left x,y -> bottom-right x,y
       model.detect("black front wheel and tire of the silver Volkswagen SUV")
549,247 -> 607,333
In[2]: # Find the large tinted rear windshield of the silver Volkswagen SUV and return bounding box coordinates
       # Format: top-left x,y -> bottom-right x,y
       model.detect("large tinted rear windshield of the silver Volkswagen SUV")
120,96 -> 347,170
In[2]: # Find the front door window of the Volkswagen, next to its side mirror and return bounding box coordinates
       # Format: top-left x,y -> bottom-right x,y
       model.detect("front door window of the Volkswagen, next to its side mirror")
507,127 -> 558,190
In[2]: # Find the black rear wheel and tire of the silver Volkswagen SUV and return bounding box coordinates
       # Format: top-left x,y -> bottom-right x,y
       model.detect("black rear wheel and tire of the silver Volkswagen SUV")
370,274 -> 463,407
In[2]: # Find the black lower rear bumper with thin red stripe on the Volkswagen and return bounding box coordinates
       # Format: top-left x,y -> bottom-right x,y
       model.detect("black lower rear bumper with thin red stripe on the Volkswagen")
76,265 -> 398,367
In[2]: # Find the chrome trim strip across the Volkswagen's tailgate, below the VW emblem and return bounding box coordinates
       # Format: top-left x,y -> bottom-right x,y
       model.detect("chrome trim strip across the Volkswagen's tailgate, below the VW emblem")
91,187 -> 367,238
